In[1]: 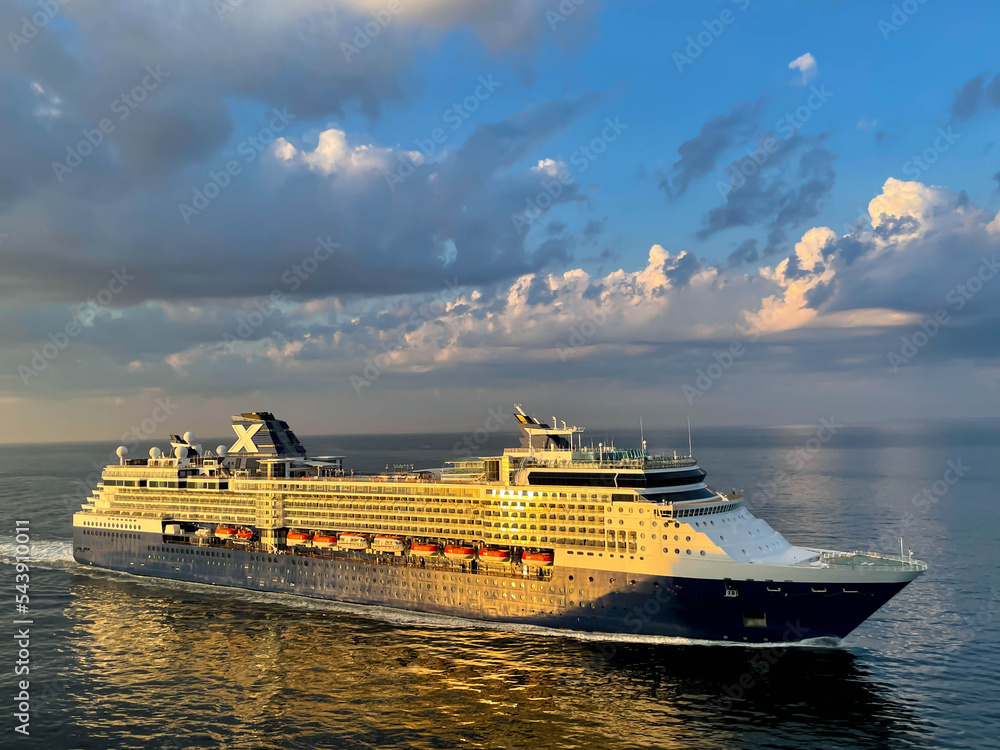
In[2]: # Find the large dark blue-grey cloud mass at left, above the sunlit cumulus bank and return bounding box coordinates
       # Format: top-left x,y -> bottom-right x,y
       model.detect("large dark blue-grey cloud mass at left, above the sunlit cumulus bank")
0,97 -> 595,304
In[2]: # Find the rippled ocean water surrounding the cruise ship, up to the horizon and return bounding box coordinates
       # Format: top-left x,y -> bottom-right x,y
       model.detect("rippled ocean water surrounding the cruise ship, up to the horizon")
0,420 -> 1000,750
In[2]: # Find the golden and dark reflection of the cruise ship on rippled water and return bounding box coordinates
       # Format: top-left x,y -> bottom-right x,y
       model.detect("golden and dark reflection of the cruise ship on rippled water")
66,576 -> 920,750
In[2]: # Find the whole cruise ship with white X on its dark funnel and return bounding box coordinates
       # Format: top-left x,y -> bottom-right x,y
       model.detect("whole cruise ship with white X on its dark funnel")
73,406 -> 927,643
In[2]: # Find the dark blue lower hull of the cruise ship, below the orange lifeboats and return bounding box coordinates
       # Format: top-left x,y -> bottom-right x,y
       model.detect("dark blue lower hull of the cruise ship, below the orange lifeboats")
74,528 -> 906,643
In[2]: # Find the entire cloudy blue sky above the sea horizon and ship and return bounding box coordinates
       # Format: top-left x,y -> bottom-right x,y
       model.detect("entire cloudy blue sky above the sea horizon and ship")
0,0 -> 1000,442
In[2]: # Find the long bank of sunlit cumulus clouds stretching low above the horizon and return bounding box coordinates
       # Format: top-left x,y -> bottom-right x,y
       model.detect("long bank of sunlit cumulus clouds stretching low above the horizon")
7,174 -> 1000,440
